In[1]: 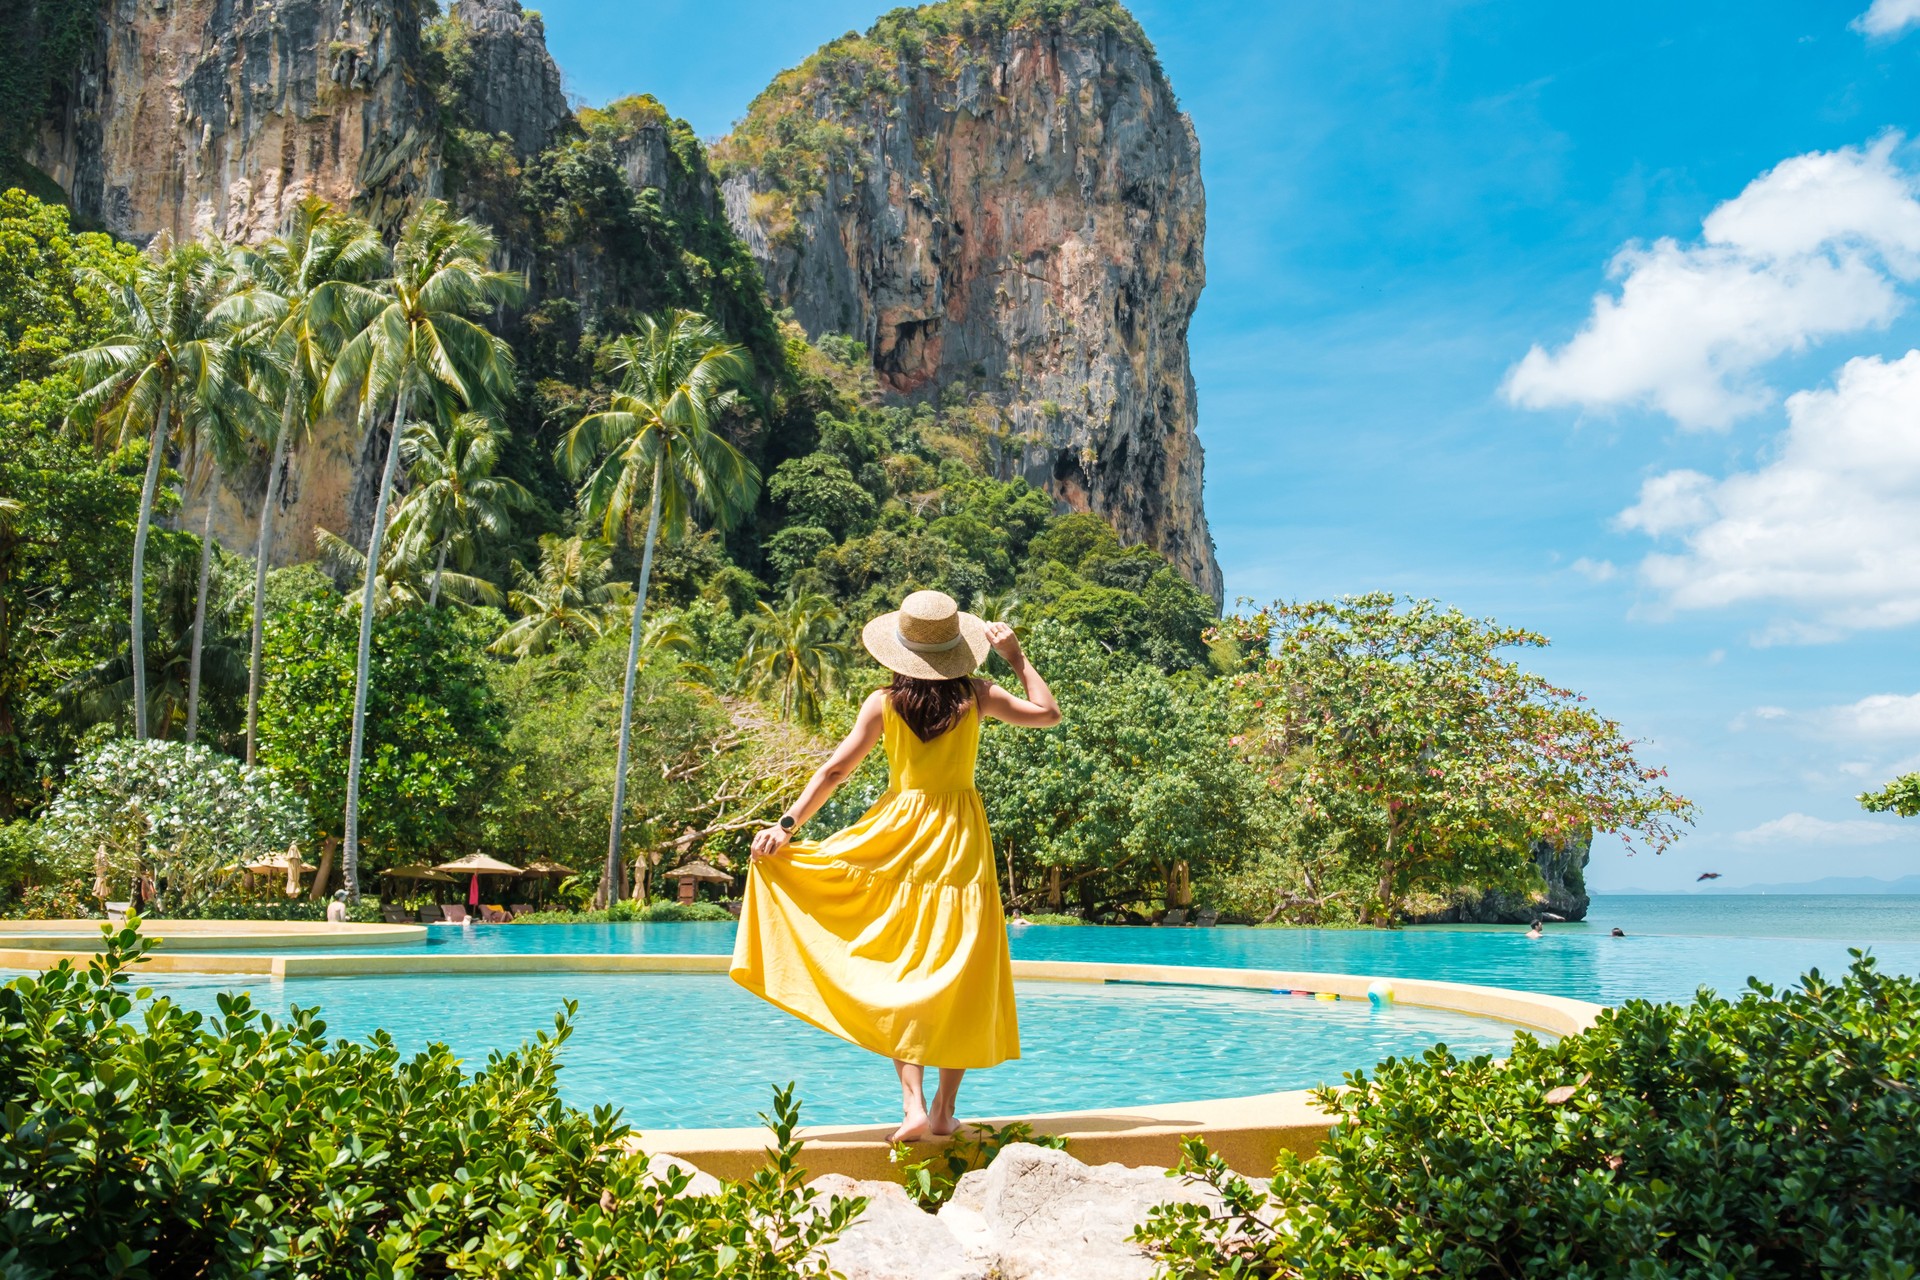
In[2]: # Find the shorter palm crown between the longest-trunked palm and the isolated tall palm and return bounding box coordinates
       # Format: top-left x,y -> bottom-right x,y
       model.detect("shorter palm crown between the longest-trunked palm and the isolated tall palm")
394,413 -> 534,608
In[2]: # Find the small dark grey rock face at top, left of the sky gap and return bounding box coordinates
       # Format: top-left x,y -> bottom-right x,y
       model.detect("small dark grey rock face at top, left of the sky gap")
453,0 -> 572,159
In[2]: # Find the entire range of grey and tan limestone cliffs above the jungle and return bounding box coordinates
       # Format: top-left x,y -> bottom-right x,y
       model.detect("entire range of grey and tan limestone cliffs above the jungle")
25,0 -> 1221,599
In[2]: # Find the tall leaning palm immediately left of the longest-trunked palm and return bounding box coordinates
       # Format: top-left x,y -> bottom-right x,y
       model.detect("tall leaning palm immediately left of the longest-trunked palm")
230,196 -> 386,764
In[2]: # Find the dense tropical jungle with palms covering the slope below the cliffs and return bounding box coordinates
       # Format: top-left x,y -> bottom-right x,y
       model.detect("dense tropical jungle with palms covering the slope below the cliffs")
0,0 -> 1688,923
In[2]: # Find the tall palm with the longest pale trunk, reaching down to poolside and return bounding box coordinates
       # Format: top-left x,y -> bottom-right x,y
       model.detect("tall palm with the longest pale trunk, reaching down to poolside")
323,200 -> 522,900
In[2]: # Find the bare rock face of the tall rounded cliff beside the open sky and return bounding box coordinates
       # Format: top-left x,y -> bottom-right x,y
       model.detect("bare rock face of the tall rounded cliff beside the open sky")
716,6 -> 1221,599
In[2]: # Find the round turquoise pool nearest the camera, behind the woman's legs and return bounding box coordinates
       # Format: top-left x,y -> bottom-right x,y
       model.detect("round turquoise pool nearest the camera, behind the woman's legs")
142,973 -> 1513,1130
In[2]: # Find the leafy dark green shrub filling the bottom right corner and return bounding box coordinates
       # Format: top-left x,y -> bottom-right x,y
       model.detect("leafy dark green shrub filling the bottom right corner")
1137,954 -> 1920,1280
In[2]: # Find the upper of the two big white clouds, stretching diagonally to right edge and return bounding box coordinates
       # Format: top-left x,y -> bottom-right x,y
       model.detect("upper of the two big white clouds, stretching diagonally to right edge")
1501,135 -> 1920,428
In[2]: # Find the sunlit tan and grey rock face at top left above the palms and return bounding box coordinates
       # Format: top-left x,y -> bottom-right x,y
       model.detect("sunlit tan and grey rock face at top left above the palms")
27,0 -> 440,240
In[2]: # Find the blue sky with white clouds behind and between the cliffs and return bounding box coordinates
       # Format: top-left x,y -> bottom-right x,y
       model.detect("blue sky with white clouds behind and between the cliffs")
529,0 -> 1920,889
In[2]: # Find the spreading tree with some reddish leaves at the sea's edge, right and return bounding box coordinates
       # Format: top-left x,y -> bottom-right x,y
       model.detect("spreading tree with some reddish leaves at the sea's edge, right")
1229,593 -> 1692,923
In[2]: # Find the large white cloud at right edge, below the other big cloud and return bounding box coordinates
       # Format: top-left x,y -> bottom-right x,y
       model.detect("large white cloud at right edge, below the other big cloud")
1620,351 -> 1920,643
